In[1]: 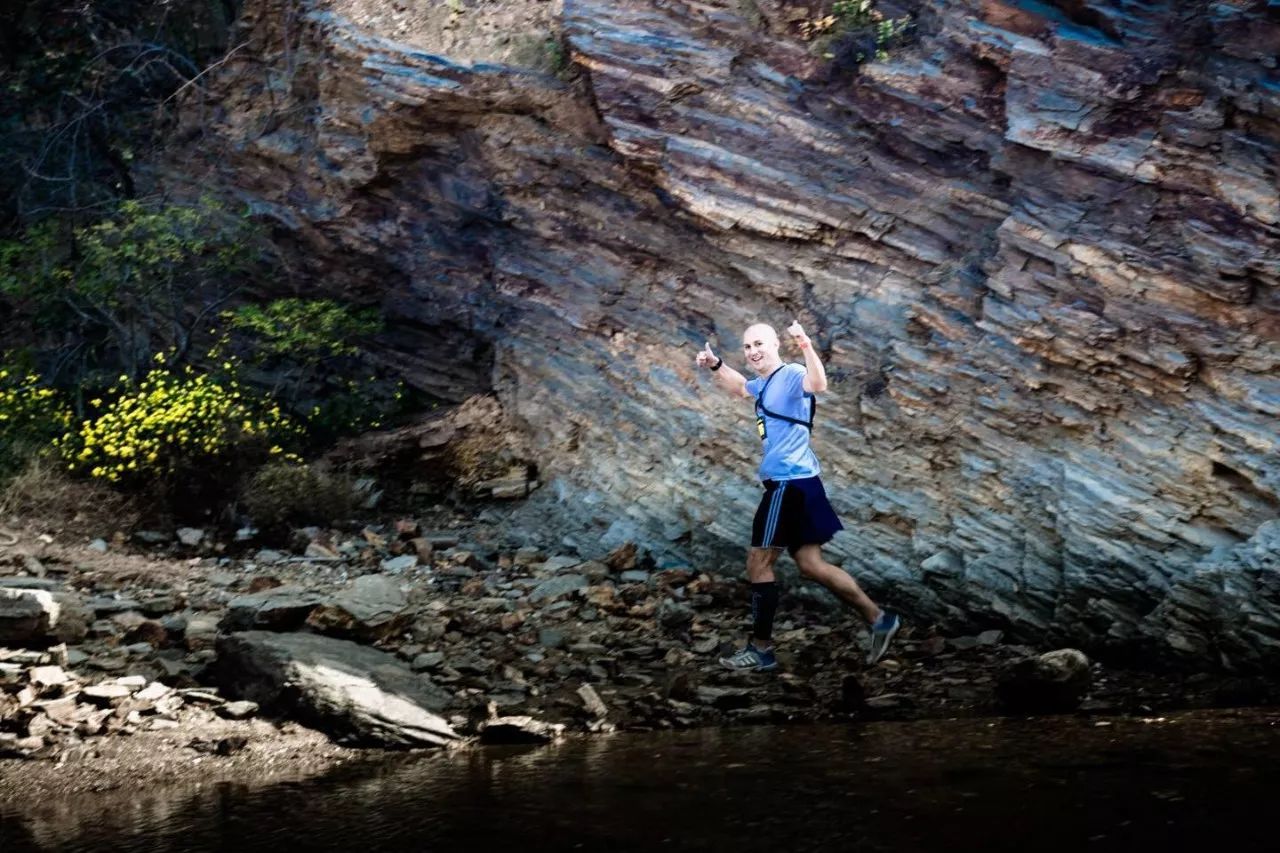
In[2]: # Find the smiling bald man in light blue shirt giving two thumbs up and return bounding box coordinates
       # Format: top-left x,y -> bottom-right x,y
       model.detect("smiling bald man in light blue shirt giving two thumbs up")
696,323 -> 901,672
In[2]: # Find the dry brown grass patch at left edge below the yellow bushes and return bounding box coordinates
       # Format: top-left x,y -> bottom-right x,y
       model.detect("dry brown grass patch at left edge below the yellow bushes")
0,456 -> 141,535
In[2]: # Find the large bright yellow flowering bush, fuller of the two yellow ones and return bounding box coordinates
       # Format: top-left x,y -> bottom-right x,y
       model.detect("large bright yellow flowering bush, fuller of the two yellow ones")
56,356 -> 298,484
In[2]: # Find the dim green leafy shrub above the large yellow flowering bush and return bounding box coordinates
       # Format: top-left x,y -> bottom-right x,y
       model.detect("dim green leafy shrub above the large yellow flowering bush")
0,197 -> 265,384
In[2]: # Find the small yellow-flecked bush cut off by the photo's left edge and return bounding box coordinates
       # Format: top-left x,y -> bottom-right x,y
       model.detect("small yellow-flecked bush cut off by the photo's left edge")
0,356 -> 72,479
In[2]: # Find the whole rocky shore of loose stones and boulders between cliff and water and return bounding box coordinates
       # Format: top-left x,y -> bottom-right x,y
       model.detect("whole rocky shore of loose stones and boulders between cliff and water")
0,502 -> 1280,808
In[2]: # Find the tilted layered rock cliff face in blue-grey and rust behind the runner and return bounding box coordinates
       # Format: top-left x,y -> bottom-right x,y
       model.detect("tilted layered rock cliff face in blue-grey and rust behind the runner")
189,0 -> 1280,666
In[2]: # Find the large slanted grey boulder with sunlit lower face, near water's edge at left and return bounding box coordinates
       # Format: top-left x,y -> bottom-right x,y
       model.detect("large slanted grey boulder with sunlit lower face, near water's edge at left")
214,631 -> 458,748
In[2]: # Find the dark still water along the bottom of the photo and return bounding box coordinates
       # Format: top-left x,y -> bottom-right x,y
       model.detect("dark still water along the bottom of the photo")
0,710 -> 1280,853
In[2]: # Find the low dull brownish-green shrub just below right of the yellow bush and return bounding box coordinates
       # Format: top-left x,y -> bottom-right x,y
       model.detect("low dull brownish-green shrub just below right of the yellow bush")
239,462 -> 356,528
